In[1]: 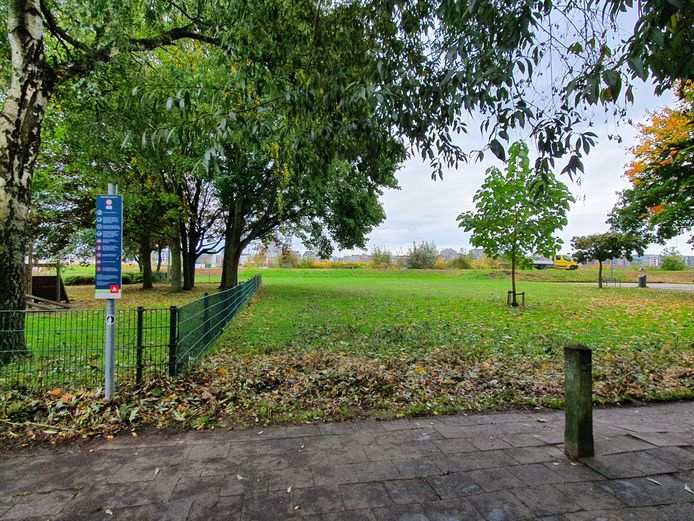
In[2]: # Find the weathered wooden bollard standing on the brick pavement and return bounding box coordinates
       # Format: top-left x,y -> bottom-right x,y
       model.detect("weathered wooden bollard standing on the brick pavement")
564,345 -> 595,460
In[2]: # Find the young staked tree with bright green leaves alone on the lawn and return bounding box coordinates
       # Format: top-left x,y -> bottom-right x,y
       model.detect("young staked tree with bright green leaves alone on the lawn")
458,141 -> 574,306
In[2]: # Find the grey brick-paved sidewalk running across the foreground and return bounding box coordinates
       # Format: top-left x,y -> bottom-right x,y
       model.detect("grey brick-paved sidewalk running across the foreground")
0,402 -> 694,521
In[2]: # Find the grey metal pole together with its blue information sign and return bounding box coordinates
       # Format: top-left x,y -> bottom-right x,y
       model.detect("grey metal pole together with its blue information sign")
95,184 -> 123,401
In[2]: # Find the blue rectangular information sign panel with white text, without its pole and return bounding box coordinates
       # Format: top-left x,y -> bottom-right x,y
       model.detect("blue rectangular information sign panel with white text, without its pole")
95,195 -> 123,298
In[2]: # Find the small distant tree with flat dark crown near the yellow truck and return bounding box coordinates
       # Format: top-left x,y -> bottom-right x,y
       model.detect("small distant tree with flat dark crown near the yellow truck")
571,231 -> 647,288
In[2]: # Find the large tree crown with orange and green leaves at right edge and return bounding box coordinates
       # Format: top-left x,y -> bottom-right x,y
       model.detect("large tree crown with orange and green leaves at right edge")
609,83 -> 694,243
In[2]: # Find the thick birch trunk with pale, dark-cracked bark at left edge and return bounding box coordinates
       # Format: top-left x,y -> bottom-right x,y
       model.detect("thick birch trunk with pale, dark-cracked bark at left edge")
0,0 -> 53,363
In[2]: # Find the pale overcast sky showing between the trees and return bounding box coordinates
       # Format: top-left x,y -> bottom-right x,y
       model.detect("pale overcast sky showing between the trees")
338,82 -> 694,255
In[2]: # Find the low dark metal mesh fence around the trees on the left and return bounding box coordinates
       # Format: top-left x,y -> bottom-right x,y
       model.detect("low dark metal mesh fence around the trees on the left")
0,275 -> 261,389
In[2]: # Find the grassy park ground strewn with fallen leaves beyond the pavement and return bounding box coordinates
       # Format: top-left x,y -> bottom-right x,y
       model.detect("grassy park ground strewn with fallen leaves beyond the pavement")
0,270 -> 694,444
